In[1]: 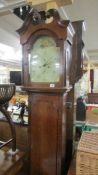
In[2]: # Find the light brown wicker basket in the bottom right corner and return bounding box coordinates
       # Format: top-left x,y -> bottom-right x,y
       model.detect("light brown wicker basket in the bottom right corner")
76,131 -> 98,175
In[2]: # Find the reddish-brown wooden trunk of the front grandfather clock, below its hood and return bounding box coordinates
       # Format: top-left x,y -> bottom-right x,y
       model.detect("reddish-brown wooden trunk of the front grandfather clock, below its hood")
29,92 -> 66,175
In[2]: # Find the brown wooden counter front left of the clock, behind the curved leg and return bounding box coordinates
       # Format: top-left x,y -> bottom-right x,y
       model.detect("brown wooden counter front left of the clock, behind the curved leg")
0,120 -> 29,153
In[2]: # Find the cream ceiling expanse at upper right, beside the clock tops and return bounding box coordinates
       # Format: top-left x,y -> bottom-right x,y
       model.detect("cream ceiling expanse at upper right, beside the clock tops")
64,0 -> 98,62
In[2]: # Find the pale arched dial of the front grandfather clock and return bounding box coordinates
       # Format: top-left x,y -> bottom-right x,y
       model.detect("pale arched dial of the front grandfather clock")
29,36 -> 60,83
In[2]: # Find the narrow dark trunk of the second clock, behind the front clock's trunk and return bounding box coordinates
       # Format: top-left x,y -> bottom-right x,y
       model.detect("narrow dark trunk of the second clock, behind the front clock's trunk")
66,87 -> 75,172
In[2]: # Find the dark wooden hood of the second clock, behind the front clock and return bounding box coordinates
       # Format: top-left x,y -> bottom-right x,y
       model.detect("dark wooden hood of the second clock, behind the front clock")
70,21 -> 84,84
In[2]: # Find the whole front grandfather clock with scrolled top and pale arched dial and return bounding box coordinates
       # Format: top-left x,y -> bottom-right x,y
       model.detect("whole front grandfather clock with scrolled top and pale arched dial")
18,9 -> 73,175
